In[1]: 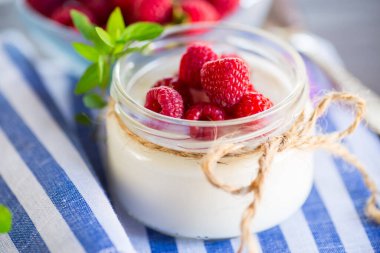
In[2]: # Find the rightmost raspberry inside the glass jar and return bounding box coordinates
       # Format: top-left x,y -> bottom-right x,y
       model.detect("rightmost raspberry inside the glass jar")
233,92 -> 273,118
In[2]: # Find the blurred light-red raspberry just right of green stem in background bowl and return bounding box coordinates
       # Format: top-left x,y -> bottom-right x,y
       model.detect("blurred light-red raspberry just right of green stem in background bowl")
181,0 -> 219,23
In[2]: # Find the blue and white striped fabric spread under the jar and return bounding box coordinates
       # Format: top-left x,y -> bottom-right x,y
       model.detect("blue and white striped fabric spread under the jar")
0,30 -> 380,253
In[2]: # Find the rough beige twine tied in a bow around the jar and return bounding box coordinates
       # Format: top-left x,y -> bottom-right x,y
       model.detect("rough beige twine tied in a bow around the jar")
110,92 -> 380,253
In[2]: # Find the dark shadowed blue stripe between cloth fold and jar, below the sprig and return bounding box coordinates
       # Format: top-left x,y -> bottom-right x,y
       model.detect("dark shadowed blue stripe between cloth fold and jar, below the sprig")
67,75 -> 108,189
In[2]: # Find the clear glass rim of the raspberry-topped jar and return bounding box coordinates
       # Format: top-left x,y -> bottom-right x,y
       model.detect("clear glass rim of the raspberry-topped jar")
113,22 -> 307,127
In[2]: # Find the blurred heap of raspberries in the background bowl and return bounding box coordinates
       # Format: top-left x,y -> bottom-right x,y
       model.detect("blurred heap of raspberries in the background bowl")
27,0 -> 239,27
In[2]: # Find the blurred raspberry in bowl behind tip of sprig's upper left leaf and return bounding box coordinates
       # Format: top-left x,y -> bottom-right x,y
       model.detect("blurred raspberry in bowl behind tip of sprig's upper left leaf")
51,2 -> 96,27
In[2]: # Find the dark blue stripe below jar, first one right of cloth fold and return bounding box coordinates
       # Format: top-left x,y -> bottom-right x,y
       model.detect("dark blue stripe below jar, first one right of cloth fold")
146,228 -> 178,253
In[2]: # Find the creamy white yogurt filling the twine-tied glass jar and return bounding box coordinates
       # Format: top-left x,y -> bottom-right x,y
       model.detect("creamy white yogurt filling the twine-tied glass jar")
107,24 -> 313,239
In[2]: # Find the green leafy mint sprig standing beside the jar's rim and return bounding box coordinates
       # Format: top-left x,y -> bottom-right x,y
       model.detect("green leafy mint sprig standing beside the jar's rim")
71,7 -> 164,113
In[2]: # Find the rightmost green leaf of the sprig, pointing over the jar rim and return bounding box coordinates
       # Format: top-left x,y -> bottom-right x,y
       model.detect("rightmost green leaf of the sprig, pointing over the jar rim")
121,22 -> 164,41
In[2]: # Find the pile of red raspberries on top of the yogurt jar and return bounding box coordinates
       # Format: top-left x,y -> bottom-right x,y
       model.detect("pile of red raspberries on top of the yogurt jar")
145,43 -> 273,121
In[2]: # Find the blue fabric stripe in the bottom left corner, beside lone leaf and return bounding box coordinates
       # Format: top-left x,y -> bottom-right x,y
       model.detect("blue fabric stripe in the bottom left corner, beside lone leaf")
0,176 -> 49,253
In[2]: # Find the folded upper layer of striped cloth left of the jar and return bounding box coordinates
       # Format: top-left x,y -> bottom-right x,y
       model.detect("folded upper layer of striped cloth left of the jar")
0,32 -> 134,253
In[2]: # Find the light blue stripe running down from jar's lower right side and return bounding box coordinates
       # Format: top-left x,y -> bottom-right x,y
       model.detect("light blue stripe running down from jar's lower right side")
302,186 -> 345,252
